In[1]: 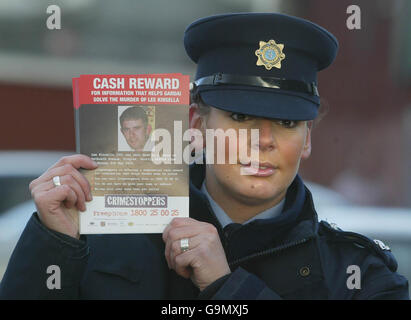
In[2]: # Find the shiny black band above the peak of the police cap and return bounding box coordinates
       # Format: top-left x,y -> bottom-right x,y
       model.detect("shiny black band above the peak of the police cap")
193,73 -> 319,97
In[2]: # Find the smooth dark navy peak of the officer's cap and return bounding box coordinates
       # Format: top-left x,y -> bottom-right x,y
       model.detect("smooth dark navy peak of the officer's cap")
199,88 -> 319,120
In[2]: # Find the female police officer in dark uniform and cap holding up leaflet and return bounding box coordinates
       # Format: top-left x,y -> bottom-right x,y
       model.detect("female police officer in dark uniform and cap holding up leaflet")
0,13 -> 408,299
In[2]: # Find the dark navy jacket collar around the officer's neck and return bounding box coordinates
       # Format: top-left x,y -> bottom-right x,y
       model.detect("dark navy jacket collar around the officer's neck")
190,164 -> 318,261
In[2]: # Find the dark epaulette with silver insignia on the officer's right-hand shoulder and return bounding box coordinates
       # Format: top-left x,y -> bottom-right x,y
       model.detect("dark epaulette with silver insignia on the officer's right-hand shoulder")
318,221 -> 398,272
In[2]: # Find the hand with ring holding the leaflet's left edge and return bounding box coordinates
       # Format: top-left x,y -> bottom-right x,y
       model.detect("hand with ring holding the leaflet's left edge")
29,154 -> 97,239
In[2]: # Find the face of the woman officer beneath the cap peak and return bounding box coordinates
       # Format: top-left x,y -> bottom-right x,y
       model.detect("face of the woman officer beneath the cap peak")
191,107 -> 311,207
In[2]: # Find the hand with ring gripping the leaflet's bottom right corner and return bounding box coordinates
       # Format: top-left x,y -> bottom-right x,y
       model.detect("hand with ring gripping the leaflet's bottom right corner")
163,218 -> 231,291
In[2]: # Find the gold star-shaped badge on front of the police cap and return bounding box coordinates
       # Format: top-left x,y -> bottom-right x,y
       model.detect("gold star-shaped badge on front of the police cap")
255,40 -> 285,70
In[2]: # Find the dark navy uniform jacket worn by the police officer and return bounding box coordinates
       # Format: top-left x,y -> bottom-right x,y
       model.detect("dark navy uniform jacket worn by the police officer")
0,165 -> 409,299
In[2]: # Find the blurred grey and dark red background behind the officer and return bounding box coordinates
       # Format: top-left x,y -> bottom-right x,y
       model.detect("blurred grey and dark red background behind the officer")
0,0 -> 411,296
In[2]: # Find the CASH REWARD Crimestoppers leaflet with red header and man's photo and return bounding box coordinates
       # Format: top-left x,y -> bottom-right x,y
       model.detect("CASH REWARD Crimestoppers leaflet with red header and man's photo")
73,74 -> 189,234
